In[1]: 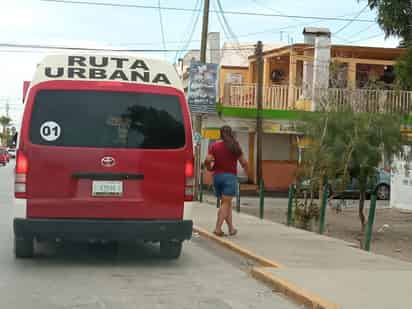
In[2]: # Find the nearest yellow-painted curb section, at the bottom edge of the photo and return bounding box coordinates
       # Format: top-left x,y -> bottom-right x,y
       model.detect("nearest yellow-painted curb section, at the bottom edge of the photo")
251,267 -> 340,309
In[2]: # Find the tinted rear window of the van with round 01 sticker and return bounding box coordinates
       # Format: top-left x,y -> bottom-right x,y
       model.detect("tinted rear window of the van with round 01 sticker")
30,90 -> 185,149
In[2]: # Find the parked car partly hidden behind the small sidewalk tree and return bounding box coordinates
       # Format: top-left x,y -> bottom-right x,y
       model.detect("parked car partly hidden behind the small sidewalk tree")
300,169 -> 391,200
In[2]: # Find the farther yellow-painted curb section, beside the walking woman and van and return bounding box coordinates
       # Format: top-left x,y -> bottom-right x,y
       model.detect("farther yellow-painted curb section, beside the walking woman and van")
193,226 -> 282,268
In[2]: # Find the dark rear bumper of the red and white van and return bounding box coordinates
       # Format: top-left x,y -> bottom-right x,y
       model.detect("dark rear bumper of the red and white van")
13,218 -> 193,241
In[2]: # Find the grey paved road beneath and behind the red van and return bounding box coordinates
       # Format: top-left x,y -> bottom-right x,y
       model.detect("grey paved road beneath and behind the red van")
0,162 -> 298,309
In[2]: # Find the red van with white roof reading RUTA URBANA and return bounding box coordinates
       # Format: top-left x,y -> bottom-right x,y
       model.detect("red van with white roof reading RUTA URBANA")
14,55 -> 194,258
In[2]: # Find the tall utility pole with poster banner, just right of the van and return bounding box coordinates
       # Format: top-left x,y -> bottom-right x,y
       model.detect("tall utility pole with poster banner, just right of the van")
194,0 -> 210,200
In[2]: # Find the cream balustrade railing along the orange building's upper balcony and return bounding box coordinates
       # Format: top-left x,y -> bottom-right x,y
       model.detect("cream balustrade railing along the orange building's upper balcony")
223,84 -> 412,113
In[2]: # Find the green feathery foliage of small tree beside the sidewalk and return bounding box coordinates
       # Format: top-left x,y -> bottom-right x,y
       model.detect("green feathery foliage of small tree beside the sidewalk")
298,109 -> 408,228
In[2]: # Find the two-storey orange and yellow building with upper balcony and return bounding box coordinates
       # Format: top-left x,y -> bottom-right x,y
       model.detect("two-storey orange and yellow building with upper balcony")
179,28 -> 412,191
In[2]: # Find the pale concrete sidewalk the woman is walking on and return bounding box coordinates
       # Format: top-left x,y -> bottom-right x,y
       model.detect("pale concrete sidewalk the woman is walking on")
192,203 -> 412,309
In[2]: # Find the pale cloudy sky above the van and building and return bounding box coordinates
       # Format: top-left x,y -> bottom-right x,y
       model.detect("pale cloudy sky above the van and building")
0,0 -> 399,127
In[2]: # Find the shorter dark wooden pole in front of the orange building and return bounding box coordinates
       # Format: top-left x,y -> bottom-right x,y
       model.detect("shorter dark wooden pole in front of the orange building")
255,41 -> 263,185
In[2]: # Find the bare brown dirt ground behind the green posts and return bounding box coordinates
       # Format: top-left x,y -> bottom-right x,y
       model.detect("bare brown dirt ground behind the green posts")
208,197 -> 412,262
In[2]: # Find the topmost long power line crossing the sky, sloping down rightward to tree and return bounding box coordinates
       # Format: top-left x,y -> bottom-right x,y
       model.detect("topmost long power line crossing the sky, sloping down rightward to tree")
39,0 -> 375,23
